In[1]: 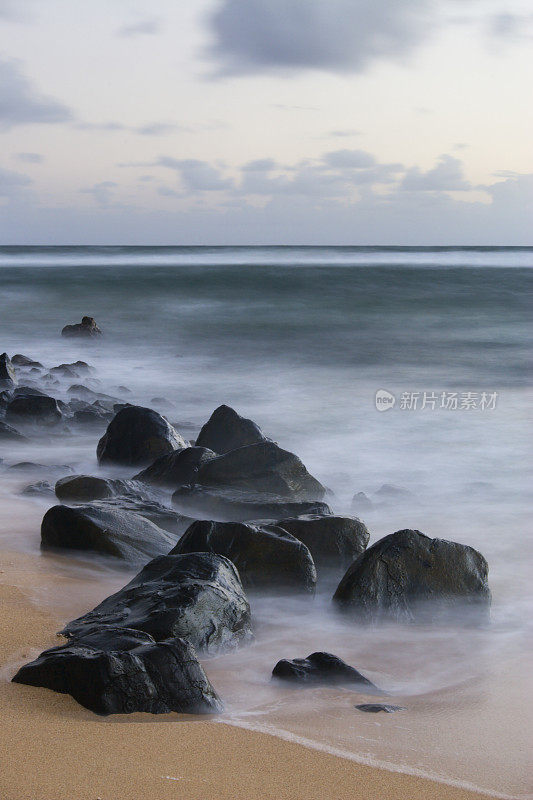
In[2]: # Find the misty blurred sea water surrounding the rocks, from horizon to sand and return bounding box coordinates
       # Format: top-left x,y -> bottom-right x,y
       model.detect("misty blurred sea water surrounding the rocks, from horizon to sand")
0,247 -> 533,797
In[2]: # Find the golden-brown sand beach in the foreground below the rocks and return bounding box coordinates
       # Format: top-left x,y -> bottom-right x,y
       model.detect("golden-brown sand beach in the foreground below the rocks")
0,551 -> 509,800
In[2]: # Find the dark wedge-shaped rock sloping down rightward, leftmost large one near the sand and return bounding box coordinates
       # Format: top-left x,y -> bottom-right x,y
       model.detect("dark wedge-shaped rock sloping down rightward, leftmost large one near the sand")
41,505 -> 176,564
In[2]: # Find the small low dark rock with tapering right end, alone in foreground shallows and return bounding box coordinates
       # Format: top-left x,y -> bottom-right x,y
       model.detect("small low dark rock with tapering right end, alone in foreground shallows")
272,653 -> 383,694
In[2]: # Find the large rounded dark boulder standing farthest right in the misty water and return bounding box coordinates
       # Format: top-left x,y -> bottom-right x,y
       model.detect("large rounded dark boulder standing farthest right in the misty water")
333,530 -> 491,623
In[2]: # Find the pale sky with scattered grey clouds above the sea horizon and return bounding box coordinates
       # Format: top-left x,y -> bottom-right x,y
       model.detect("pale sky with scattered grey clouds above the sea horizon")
0,0 -> 533,245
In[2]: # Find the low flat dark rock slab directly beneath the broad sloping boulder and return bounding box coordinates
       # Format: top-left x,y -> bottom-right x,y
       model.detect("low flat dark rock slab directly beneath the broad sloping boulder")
172,486 -> 331,522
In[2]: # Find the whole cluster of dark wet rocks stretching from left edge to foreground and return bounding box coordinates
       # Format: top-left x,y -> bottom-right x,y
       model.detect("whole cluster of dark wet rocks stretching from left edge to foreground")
7,354 -> 490,713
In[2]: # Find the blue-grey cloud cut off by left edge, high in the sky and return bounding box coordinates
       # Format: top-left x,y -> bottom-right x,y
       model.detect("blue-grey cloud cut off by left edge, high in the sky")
0,61 -> 73,130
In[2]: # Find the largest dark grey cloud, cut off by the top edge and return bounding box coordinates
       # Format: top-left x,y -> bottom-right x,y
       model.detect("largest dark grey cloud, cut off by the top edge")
209,0 -> 433,74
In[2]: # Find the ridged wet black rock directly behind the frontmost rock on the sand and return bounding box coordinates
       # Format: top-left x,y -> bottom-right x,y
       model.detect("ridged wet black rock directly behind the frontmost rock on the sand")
62,553 -> 253,653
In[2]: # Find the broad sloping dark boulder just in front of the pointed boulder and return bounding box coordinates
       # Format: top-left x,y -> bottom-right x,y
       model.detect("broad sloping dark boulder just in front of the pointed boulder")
196,442 -> 326,501
